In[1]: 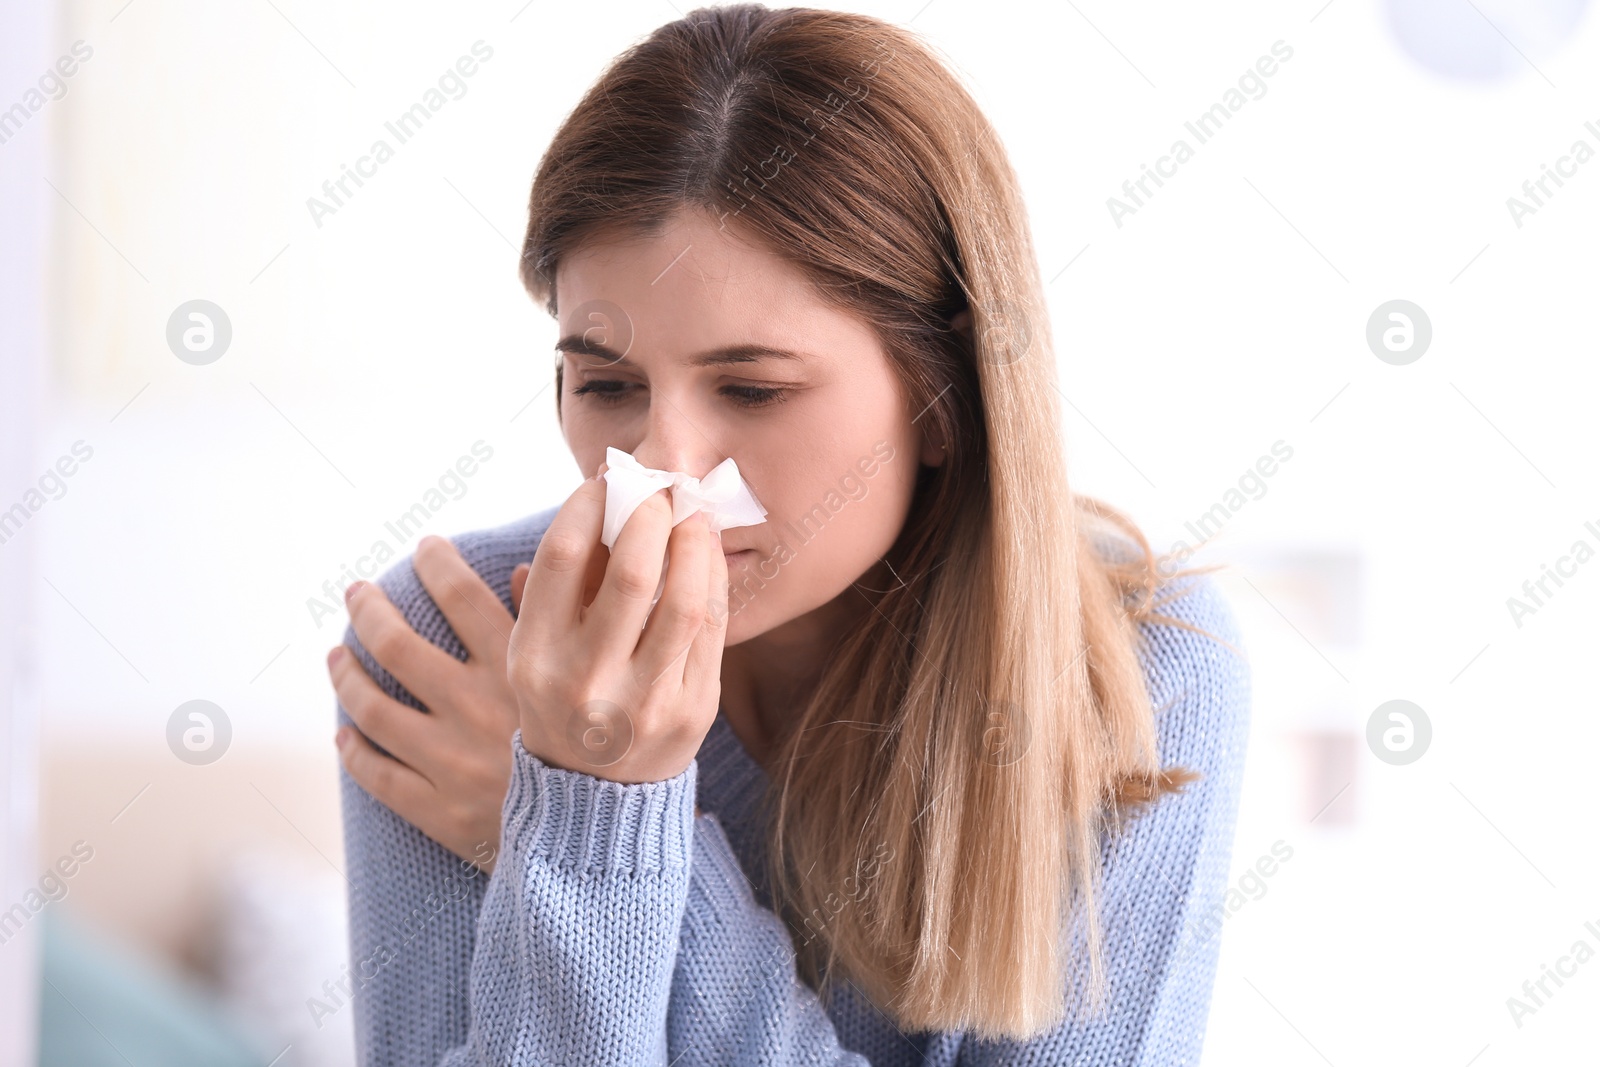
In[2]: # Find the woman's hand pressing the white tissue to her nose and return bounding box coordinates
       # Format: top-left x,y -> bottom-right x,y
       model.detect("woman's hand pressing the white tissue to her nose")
507,475 -> 728,782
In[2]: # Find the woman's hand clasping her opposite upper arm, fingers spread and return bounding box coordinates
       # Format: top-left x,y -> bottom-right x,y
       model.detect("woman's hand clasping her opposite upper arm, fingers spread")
328,537 -> 528,872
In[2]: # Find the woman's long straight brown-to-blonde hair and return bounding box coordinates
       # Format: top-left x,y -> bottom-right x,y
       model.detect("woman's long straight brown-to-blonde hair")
520,3 -> 1211,1038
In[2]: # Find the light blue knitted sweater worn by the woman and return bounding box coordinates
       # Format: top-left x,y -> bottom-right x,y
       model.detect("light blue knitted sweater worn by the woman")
338,507 -> 1250,1067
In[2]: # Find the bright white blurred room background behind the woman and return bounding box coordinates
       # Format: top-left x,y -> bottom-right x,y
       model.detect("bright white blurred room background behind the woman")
0,0 -> 1600,1067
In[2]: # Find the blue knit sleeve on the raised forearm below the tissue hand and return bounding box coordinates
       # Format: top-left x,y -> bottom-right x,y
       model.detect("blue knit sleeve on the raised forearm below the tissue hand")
443,729 -> 698,1067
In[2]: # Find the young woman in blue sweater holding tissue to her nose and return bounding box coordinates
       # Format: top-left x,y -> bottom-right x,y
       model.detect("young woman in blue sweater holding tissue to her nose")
330,5 -> 1250,1067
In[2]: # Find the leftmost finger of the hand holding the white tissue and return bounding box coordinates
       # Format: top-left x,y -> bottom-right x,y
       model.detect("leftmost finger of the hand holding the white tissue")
517,480 -> 605,648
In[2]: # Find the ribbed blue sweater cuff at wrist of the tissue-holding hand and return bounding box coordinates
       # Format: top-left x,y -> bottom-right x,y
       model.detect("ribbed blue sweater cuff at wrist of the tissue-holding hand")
502,729 -> 699,873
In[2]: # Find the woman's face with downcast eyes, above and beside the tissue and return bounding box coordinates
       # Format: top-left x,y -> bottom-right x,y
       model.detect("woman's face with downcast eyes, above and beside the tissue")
555,213 -> 944,646
